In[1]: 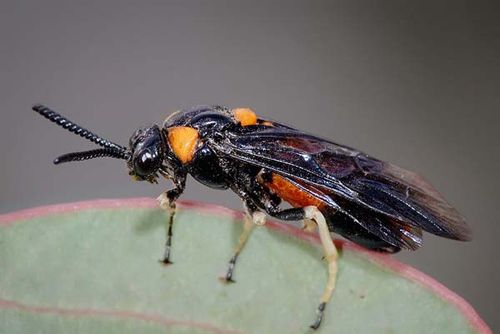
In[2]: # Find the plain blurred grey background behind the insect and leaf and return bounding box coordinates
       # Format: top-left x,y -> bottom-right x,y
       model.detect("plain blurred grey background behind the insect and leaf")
0,1 -> 500,329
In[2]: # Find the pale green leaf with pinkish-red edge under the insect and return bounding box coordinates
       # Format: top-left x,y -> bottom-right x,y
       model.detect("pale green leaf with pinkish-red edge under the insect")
0,199 -> 489,333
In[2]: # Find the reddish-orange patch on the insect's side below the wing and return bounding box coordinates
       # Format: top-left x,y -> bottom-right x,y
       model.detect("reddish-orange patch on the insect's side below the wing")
265,174 -> 323,208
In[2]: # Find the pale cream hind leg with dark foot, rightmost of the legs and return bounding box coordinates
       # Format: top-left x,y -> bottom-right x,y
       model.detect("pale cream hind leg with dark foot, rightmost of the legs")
304,206 -> 338,329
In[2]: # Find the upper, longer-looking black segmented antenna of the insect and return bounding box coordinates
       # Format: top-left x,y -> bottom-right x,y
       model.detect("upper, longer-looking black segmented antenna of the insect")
32,104 -> 127,152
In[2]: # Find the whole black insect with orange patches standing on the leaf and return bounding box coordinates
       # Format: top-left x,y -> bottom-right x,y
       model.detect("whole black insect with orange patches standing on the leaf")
33,105 -> 470,329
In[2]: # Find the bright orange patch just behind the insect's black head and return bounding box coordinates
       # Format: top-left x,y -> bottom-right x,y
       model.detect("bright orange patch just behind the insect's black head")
168,126 -> 200,164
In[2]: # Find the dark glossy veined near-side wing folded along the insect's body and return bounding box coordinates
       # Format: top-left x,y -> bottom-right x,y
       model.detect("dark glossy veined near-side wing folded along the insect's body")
212,123 -> 470,249
